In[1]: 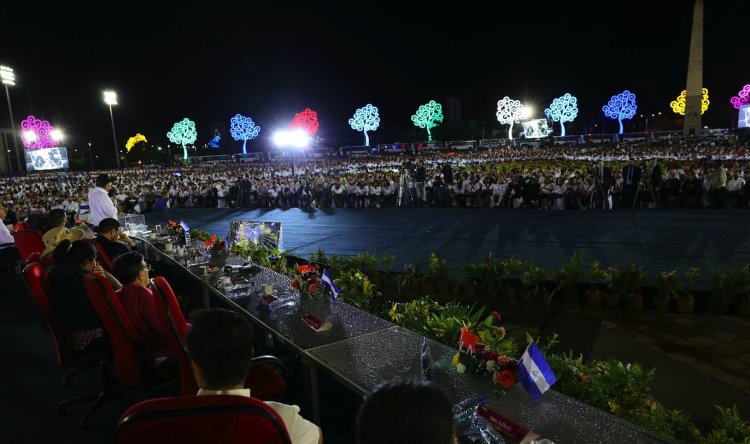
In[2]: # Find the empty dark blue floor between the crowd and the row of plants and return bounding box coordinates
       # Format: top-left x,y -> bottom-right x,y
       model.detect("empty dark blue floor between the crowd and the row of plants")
146,208 -> 750,280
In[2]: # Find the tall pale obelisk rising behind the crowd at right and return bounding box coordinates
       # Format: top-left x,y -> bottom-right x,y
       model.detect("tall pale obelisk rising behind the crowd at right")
682,0 -> 703,136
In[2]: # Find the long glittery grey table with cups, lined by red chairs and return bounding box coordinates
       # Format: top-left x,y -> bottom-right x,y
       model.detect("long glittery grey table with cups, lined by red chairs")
134,237 -> 666,443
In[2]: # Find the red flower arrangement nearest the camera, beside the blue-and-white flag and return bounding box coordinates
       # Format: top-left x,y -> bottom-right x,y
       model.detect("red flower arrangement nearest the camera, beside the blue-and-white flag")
453,311 -> 518,390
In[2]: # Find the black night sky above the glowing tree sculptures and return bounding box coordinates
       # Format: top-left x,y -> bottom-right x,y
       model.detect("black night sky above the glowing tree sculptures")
0,0 -> 750,158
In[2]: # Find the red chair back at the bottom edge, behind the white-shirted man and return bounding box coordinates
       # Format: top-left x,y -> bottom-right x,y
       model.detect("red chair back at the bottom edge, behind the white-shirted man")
114,395 -> 292,444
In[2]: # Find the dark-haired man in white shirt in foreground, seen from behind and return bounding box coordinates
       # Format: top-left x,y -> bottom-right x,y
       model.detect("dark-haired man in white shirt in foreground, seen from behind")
186,309 -> 323,444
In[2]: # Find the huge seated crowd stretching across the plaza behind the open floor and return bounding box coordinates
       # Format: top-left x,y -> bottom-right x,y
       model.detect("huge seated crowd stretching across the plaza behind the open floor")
0,142 -> 750,222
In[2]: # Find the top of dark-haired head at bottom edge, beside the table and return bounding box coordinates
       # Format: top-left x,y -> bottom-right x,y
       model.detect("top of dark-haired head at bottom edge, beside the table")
357,379 -> 456,444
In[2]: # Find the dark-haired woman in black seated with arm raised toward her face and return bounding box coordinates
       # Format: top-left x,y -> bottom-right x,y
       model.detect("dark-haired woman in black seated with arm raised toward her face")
49,239 -> 121,351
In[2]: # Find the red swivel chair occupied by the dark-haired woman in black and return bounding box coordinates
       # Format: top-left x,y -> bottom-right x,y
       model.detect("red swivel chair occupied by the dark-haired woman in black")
23,262 -> 111,418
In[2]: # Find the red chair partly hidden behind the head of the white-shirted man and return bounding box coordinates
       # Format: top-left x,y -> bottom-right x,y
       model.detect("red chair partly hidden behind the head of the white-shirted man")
151,276 -> 286,400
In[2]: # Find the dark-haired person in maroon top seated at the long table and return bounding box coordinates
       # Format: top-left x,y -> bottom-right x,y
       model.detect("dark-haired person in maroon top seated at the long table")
111,253 -> 167,339
